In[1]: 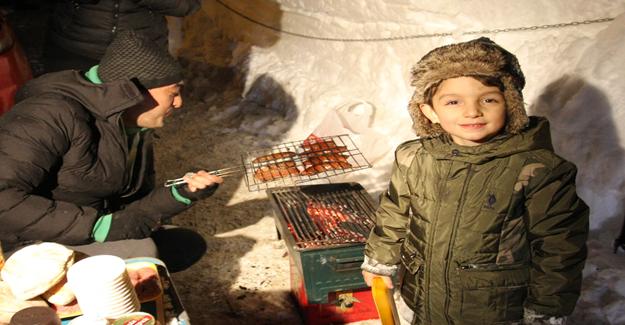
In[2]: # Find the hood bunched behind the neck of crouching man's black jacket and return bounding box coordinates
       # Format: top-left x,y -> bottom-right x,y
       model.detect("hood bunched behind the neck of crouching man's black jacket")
16,70 -> 144,119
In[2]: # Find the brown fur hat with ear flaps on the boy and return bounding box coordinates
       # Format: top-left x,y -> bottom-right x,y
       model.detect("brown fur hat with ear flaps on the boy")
408,37 -> 528,137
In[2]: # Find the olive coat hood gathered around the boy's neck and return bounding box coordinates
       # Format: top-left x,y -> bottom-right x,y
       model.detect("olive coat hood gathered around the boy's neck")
421,116 -> 553,164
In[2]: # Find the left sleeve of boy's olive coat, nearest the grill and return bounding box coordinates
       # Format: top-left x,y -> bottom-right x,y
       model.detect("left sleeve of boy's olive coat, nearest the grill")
365,145 -> 414,265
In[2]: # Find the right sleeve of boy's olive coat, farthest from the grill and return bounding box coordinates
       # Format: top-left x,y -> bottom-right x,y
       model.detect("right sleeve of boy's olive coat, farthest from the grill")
525,161 -> 589,316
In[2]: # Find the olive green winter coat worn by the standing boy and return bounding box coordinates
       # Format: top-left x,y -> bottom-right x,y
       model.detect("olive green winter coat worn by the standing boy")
365,117 -> 588,325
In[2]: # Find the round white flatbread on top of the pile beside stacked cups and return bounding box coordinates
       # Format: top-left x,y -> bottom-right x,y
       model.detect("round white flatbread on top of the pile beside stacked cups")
0,243 -> 74,300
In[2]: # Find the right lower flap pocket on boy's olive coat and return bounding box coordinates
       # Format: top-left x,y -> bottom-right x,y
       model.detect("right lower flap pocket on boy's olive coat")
459,264 -> 529,324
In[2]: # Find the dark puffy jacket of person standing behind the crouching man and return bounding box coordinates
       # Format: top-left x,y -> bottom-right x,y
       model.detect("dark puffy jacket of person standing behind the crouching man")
48,0 -> 200,60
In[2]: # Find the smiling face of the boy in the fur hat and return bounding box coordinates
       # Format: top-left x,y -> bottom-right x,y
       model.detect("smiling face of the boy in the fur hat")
420,77 -> 506,146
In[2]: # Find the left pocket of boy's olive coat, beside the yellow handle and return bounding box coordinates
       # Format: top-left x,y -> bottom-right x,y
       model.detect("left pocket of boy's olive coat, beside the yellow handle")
399,246 -> 424,310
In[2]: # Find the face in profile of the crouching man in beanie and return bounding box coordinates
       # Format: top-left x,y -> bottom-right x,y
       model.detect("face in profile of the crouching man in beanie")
123,83 -> 182,128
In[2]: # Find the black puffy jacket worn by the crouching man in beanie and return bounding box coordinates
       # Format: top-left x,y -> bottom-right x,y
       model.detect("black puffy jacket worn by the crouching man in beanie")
0,71 -> 188,250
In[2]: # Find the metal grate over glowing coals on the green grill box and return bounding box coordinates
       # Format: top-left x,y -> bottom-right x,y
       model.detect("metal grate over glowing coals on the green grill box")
270,183 -> 375,250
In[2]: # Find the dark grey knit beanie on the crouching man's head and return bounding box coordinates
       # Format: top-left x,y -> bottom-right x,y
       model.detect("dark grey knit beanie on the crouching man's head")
98,30 -> 182,89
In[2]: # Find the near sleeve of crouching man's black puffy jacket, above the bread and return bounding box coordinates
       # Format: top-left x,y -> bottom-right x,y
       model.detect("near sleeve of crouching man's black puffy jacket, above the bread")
0,99 -> 98,244
